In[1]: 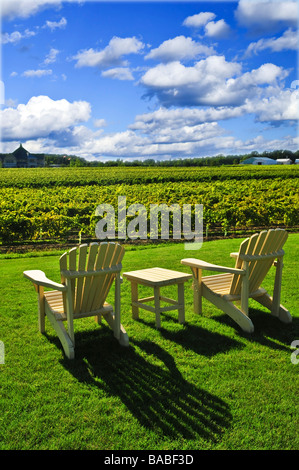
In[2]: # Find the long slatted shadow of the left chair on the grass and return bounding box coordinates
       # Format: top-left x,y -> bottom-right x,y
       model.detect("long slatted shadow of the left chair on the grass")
63,332 -> 231,442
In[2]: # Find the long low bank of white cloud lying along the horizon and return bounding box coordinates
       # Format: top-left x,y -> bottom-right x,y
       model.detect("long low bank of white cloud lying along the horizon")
11,129 -> 298,160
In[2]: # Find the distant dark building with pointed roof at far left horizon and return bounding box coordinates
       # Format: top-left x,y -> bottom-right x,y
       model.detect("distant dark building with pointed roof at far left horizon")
0,144 -> 45,168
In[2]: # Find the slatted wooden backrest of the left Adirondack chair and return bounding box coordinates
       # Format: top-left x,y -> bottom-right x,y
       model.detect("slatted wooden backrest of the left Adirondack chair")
60,242 -> 125,314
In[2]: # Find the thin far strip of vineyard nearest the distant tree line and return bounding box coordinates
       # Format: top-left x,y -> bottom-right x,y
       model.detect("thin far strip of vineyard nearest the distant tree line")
0,165 -> 299,188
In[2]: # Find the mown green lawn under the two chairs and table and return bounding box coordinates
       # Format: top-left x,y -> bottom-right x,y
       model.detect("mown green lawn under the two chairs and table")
0,234 -> 299,450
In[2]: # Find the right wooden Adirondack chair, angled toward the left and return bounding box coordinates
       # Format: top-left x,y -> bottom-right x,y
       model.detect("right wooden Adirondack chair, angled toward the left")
181,229 -> 292,333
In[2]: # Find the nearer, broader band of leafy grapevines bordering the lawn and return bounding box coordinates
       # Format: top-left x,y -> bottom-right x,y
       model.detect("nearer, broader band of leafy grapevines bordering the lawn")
0,173 -> 299,243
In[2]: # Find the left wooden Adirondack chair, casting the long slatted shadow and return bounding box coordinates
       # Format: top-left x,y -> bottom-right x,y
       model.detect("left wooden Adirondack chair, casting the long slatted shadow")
23,243 -> 129,359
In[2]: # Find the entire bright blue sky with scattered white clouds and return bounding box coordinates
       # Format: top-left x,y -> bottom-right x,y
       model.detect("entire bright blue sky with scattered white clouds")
0,0 -> 299,160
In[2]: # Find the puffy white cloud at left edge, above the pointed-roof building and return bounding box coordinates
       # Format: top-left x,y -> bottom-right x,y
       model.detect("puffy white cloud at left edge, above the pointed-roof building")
0,96 -> 91,141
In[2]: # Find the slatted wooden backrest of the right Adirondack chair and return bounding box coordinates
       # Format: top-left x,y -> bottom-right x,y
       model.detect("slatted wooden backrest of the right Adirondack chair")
230,229 -> 288,295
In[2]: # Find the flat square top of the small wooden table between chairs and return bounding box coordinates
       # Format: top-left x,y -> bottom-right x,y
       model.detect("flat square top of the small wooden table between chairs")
123,268 -> 192,286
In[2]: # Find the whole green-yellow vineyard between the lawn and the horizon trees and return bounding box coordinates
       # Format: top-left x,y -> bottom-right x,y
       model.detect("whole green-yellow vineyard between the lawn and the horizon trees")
0,165 -> 299,244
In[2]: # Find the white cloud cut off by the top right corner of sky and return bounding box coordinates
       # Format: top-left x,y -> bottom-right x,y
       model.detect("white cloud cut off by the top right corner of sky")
236,0 -> 298,31
